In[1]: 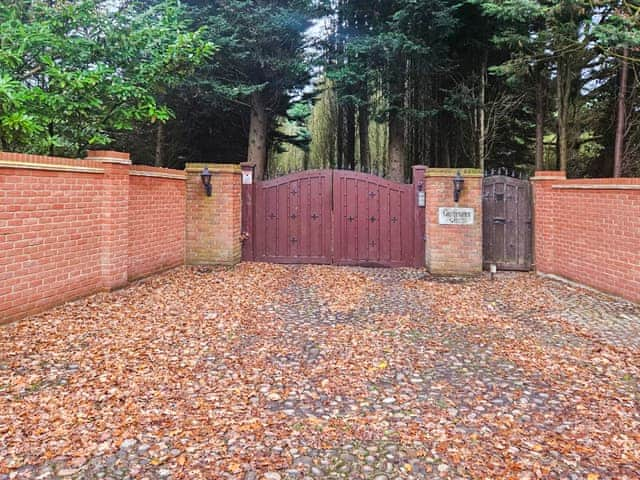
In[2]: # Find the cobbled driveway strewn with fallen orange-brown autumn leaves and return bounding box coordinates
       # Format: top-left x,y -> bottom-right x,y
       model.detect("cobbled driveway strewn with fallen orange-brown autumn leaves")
0,264 -> 640,480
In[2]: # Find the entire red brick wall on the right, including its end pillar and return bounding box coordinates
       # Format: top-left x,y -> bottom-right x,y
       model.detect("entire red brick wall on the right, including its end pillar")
533,171 -> 640,302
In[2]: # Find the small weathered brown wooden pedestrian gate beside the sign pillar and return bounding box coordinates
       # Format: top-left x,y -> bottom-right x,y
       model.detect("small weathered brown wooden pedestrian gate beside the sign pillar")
482,175 -> 533,271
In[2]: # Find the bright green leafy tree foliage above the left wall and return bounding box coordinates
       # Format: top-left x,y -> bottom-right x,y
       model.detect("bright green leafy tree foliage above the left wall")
0,0 -> 213,155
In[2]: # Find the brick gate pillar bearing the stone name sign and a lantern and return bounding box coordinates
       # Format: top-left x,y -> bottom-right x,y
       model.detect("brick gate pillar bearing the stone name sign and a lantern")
425,168 -> 482,275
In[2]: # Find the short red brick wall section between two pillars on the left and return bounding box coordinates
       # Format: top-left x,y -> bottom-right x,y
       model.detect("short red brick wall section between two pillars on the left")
128,166 -> 186,280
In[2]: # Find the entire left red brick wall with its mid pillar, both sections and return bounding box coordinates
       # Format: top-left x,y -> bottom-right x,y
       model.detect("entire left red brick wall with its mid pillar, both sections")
0,152 -> 185,323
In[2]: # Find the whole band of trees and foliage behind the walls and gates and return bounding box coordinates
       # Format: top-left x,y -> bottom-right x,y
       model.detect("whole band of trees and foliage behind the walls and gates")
0,0 -> 640,181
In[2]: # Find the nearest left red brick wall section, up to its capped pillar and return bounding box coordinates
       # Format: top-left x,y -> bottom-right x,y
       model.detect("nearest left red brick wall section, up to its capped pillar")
0,153 -> 104,322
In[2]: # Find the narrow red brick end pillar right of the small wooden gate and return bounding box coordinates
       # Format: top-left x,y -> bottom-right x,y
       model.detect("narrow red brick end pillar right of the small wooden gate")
531,170 -> 567,273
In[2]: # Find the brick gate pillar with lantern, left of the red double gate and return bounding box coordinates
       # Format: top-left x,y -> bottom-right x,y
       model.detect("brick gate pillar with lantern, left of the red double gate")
186,163 -> 242,265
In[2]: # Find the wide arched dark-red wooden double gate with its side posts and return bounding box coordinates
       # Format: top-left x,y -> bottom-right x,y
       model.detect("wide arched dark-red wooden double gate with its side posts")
242,170 -> 424,267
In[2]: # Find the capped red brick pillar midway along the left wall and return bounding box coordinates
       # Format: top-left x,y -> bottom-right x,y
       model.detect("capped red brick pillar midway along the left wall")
87,151 -> 131,290
